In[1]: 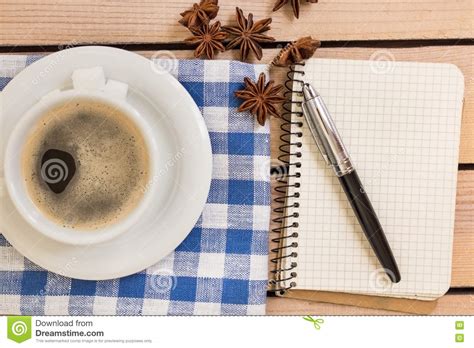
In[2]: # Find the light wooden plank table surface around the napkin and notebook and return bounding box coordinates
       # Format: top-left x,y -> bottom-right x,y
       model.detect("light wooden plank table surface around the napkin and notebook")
0,0 -> 474,315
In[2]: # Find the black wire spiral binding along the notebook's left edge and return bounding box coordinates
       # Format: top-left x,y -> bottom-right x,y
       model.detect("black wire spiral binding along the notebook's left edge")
269,63 -> 305,296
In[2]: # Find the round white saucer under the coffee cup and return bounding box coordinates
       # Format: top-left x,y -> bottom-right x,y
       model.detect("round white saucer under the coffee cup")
0,46 -> 212,280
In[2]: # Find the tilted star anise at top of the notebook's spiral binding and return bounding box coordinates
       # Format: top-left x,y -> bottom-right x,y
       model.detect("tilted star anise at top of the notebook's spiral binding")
272,36 -> 321,66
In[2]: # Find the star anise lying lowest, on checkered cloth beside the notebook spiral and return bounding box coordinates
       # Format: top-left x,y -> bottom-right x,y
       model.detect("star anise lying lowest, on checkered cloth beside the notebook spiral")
235,73 -> 285,126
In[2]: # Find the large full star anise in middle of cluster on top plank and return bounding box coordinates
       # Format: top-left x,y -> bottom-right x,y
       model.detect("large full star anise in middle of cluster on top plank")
222,7 -> 275,60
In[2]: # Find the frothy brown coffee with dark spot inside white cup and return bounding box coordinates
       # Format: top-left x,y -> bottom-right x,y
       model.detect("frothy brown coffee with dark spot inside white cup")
21,98 -> 149,230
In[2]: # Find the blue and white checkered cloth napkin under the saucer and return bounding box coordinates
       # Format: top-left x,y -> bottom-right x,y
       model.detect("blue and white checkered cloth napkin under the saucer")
0,56 -> 270,315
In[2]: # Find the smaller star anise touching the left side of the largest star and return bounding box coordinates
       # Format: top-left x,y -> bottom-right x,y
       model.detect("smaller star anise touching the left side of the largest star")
184,21 -> 227,59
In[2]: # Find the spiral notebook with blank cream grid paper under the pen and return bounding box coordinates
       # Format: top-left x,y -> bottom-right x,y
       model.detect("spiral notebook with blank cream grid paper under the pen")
272,59 -> 464,300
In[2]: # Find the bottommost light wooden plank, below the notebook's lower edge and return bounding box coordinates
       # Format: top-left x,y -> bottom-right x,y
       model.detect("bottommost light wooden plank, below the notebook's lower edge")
267,292 -> 474,316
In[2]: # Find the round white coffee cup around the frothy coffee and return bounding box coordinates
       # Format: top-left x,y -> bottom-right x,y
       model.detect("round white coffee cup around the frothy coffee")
4,89 -> 158,245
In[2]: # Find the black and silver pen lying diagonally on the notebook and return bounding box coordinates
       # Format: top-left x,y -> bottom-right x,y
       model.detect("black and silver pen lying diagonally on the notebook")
302,83 -> 401,283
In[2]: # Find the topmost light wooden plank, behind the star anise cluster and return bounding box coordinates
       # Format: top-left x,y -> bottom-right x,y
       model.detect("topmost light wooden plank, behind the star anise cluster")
0,0 -> 473,46
